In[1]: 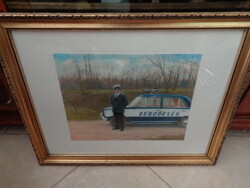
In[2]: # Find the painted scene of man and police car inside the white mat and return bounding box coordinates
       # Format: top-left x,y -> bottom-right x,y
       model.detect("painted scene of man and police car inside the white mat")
53,53 -> 202,140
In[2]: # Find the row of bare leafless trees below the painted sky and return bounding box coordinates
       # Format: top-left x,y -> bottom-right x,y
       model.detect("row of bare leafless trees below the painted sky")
59,54 -> 201,95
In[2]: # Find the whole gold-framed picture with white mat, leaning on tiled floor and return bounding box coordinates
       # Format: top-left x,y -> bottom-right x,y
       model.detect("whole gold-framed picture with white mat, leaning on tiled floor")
0,13 -> 250,165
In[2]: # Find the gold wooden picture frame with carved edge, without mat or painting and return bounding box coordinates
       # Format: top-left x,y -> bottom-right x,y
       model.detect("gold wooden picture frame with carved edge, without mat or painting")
0,13 -> 250,165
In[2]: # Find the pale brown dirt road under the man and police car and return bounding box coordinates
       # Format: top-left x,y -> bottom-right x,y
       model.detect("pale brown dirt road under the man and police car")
69,120 -> 186,140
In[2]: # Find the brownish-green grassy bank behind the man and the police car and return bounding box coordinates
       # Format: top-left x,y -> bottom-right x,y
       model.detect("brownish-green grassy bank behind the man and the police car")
62,89 -> 193,121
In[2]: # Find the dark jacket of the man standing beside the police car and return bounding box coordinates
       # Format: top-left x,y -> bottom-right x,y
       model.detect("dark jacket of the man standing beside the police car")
111,93 -> 128,113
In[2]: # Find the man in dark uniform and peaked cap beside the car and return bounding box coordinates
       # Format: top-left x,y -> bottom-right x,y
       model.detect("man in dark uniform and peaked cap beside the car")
111,85 -> 128,131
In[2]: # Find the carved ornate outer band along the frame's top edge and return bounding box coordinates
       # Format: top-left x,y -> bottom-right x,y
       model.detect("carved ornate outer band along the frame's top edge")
0,12 -> 250,20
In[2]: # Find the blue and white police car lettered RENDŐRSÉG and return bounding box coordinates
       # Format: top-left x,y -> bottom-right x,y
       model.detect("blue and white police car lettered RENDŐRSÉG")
101,94 -> 191,127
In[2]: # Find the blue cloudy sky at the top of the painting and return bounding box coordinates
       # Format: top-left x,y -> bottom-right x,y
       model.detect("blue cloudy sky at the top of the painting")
53,53 -> 202,75
